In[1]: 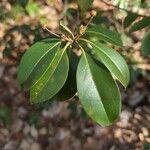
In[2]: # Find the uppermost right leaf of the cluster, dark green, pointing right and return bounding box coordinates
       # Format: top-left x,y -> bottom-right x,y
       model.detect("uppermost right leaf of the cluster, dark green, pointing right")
85,26 -> 123,47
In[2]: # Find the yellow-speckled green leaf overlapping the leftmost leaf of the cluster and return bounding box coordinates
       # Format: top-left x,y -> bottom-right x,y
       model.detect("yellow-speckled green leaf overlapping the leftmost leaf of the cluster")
30,43 -> 69,103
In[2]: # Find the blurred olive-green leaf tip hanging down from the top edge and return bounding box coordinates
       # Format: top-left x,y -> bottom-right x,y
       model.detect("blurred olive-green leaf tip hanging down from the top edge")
78,0 -> 93,13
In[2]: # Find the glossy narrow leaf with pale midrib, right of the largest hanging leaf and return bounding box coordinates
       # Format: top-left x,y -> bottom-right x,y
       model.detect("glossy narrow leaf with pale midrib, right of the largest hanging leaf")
81,40 -> 130,87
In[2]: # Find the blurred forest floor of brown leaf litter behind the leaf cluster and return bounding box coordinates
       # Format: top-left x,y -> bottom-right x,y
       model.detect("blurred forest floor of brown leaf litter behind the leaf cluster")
0,0 -> 150,150
